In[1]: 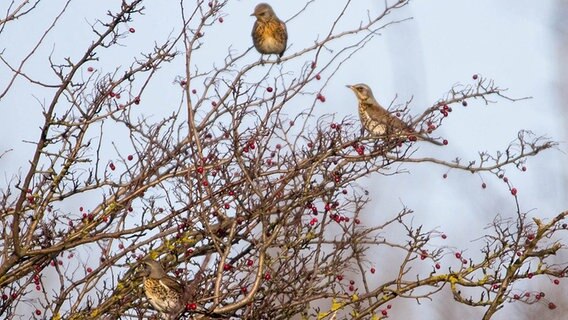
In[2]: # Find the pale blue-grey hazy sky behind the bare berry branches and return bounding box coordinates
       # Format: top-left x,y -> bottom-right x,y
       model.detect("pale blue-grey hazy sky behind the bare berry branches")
0,0 -> 568,319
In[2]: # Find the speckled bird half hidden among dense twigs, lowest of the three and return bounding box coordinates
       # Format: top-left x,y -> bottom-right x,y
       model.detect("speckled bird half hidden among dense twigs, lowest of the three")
142,257 -> 185,319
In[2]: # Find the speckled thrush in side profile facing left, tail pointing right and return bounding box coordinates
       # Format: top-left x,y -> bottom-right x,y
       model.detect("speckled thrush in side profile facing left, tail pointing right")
347,83 -> 443,146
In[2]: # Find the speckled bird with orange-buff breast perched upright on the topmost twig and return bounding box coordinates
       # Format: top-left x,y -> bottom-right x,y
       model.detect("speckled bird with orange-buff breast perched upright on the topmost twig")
251,3 -> 288,59
